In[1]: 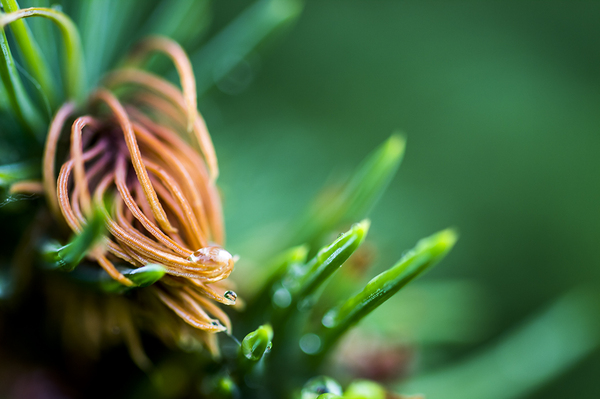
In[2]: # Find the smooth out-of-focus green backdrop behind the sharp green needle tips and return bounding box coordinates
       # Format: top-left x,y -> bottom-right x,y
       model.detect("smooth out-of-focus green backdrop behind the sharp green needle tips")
200,0 -> 600,399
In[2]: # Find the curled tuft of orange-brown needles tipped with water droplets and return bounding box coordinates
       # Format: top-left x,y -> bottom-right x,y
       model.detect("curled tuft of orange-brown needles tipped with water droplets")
44,38 -> 234,352
